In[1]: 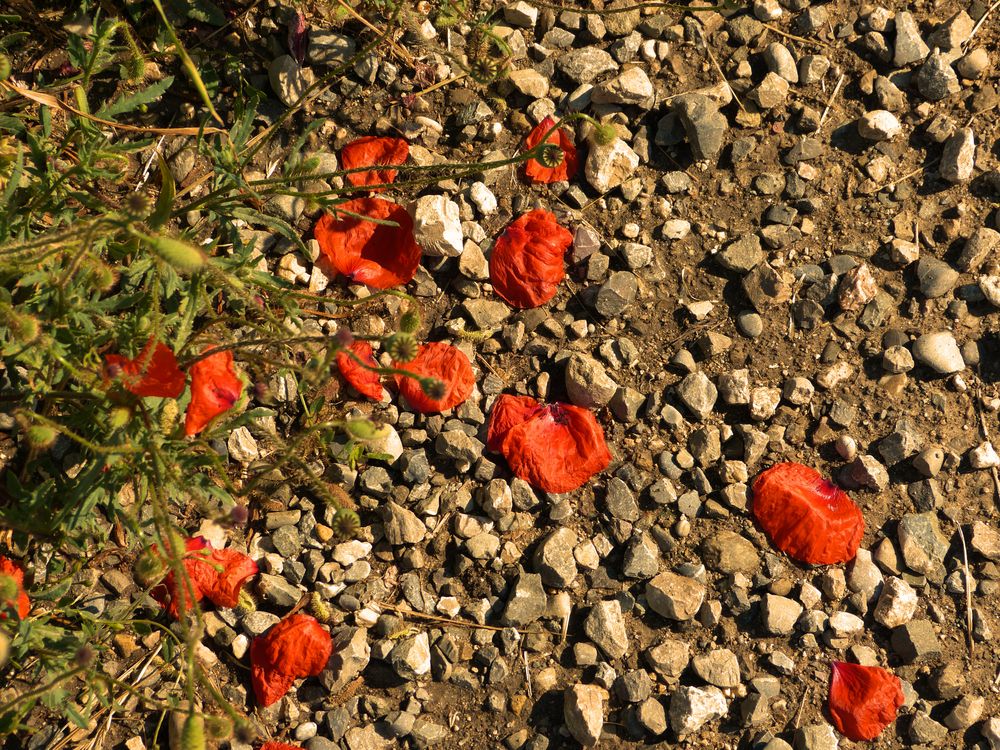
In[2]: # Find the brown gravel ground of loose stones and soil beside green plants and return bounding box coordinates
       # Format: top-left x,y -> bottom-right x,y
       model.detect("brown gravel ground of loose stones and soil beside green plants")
30,0 -> 1000,750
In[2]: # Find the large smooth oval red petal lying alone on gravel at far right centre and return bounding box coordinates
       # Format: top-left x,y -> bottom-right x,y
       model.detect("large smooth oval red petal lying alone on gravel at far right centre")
753,463 -> 865,565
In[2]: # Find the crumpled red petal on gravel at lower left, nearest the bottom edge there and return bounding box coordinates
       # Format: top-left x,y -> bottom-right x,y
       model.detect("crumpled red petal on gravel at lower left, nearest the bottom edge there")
250,614 -> 333,706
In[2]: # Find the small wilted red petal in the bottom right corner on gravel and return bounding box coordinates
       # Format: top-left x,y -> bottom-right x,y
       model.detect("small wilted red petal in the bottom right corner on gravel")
827,661 -> 904,742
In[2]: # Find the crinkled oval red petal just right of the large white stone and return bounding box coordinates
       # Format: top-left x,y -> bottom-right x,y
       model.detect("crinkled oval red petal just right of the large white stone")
490,209 -> 573,307
